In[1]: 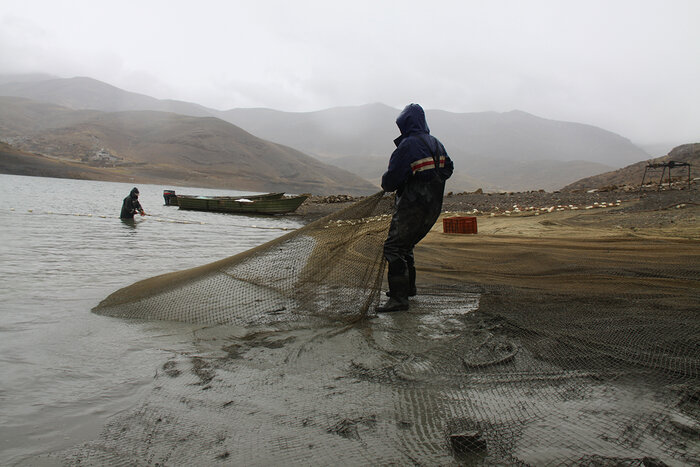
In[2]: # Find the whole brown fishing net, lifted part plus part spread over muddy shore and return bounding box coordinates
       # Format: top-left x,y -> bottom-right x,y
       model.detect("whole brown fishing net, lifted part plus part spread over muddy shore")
57,194 -> 700,466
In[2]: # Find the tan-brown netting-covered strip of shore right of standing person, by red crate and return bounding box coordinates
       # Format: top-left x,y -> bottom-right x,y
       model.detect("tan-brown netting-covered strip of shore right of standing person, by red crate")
416,192 -> 700,292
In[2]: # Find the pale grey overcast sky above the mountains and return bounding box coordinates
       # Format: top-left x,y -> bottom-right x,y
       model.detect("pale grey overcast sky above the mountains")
0,0 -> 700,143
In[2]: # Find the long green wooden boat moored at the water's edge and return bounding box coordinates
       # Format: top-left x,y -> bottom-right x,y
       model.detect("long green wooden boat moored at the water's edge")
177,193 -> 308,214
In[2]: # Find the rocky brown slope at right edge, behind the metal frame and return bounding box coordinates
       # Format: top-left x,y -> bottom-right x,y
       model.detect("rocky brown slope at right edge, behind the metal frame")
563,143 -> 700,191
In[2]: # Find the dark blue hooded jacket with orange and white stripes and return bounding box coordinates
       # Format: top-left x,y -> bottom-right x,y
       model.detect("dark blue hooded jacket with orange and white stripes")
382,104 -> 454,196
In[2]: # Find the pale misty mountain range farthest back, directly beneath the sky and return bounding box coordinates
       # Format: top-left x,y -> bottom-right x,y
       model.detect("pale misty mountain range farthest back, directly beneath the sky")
0,77 -> 649,191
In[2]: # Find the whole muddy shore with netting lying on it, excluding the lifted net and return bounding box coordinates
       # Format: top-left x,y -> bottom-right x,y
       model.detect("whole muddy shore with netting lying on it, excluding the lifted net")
30,187 -> 700,465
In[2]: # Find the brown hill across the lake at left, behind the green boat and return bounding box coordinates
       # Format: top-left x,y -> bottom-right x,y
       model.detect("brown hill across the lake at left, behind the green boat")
0,97 -> 379,195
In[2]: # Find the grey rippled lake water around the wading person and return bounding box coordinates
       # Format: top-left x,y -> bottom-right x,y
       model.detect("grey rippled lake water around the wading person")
0,175 -> 303,465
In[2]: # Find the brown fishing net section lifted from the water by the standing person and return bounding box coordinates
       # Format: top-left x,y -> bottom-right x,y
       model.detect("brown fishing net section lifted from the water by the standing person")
94,192 -> 393,326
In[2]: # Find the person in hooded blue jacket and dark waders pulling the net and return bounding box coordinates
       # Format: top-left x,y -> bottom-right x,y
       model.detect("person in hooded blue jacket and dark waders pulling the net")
377,104 -> 454,312
